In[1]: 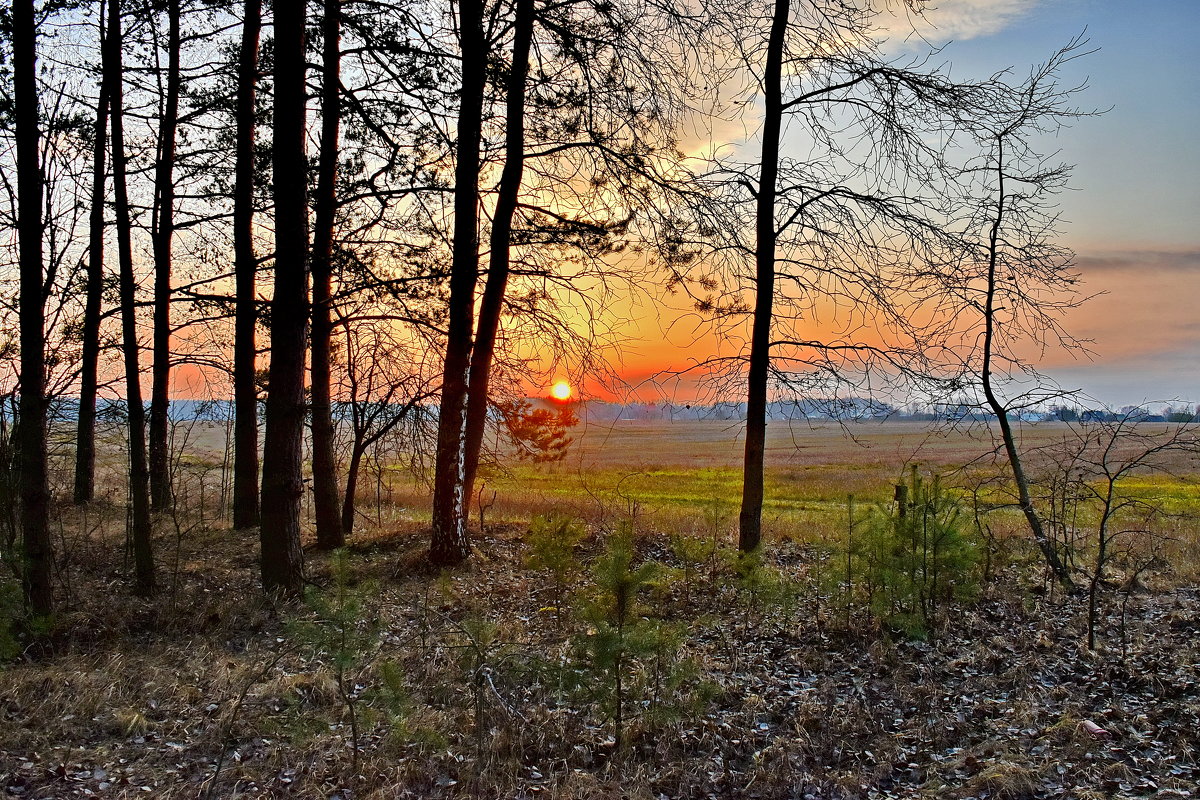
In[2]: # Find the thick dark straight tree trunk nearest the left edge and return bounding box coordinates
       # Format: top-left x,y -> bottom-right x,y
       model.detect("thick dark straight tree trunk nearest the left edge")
12,0 -> 54,616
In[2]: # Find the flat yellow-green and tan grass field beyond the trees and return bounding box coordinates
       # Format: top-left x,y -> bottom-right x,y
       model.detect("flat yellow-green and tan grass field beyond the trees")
61,412 -> 1200,561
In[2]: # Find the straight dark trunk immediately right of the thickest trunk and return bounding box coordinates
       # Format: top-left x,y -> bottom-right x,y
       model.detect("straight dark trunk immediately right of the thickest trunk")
310,0 -> 346,551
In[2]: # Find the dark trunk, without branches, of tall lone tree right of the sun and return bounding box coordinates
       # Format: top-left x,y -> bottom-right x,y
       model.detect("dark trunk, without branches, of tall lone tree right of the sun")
738,0 -> 791,553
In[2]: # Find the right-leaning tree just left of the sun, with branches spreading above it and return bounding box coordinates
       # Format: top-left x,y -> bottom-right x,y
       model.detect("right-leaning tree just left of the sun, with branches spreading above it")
463,0 -> 691,520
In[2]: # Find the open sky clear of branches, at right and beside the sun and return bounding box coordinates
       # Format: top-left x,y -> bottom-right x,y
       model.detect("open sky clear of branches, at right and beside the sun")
609,0 -> 1200,407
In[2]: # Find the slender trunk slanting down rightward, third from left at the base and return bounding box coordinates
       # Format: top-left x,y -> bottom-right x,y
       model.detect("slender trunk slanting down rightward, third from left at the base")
106,0 -> 155,595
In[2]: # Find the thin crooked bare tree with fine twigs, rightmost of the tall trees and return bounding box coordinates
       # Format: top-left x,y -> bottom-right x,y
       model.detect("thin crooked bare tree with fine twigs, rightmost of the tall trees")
948,38 -> 1086,587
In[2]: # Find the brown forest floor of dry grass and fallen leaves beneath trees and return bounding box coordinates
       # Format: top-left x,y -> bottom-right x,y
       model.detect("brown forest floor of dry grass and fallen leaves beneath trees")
0,509 -> 1200,800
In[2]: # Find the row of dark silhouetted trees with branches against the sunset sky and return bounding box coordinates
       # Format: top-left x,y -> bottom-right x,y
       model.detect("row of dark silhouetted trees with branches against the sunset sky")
0,0 -> 1086,614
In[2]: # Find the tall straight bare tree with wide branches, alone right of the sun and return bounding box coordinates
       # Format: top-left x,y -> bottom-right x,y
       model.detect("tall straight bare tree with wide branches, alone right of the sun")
701,0 -> 986,552
